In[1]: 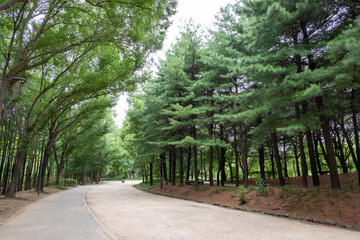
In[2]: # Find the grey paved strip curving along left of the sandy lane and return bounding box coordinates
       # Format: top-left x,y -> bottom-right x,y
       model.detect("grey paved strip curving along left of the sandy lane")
0,185 -> 109,240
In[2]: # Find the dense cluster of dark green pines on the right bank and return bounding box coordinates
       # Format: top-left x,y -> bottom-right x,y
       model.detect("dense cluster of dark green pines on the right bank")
123,0 -> 360,188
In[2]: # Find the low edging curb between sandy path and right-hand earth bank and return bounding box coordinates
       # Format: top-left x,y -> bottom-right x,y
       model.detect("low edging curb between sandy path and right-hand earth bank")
133,185 -> 360,232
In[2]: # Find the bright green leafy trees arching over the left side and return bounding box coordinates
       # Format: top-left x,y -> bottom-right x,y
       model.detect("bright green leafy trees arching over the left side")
0,0 -> 176,197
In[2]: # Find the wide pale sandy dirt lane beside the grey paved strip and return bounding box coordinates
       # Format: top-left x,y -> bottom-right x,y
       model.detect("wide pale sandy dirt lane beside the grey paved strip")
86,182 -> 360,240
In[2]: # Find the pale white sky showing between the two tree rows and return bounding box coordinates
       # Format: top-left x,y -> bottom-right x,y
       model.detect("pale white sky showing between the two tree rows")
114,0 -> 236,127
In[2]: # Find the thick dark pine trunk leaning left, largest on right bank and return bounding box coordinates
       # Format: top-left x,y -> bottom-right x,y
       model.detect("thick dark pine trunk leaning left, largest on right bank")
315,96 -> 341,188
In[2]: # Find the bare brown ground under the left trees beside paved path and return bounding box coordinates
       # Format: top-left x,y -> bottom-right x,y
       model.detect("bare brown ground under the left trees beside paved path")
0,187 -> 63,226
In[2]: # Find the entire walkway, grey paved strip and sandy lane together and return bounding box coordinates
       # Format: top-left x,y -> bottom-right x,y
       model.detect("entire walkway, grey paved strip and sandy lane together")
0,182 -> 360,240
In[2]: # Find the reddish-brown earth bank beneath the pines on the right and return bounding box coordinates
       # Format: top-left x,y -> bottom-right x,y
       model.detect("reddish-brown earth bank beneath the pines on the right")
140,173 -> 360,230
